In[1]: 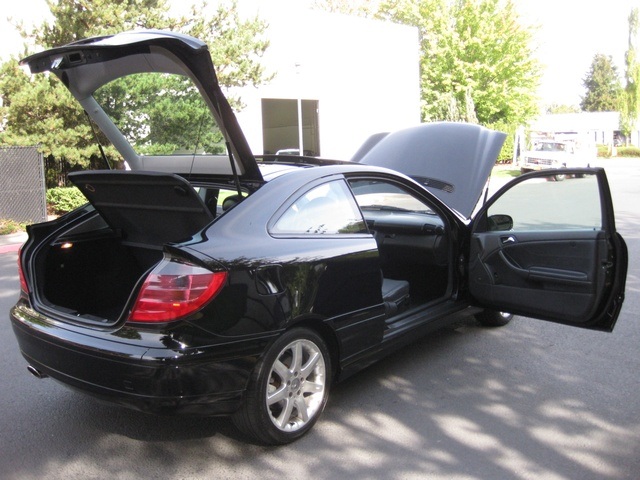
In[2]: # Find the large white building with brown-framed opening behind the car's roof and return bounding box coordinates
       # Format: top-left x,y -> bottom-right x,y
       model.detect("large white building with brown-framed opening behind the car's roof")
238,2 -> 420,159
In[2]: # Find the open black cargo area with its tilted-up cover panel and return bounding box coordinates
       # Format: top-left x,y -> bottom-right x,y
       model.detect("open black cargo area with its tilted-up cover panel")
34,171 -> 214,326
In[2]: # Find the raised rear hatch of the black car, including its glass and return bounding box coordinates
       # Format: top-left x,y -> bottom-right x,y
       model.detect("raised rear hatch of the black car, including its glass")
21,30 -> 262,182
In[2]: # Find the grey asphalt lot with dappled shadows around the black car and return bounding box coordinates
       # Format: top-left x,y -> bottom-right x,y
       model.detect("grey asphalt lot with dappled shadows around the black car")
0,159 -> 640,480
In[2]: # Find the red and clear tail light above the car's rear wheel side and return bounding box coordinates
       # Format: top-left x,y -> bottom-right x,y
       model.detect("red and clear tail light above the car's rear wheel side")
129,258 -> 227,323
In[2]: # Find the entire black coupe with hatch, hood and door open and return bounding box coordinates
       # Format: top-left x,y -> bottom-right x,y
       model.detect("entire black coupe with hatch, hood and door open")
11,31 -> 627,444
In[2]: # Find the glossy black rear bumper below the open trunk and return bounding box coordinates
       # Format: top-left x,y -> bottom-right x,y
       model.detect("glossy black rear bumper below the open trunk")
11,303 -> 265,415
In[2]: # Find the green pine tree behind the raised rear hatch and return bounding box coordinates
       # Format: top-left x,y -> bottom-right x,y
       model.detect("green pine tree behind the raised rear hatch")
0,0 -> 269,175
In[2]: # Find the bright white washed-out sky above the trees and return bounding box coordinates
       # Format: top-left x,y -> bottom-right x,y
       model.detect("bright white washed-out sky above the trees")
0,0 -> 640,105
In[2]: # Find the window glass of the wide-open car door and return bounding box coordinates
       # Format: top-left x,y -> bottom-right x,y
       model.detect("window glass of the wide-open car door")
487,174 -> 602,231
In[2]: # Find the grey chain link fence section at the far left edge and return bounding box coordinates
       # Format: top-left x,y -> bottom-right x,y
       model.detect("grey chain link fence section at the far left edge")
0,147 -> 47,223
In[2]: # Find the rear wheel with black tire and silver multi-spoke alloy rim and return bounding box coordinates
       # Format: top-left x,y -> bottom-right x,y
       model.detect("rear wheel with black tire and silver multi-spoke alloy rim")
232,328 -> 331,445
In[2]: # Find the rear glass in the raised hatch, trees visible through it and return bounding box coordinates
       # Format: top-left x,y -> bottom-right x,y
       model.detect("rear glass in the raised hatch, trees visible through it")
94,73 -> 225,155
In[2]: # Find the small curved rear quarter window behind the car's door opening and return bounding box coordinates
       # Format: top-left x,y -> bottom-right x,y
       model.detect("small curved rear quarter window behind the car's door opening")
271,180 -> 367,235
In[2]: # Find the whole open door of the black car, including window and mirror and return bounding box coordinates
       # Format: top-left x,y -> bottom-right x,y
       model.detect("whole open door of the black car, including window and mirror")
468,168 -> 628,331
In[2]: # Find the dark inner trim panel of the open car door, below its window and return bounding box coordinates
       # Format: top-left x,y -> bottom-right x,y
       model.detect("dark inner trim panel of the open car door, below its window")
469,231 -> 608,322
